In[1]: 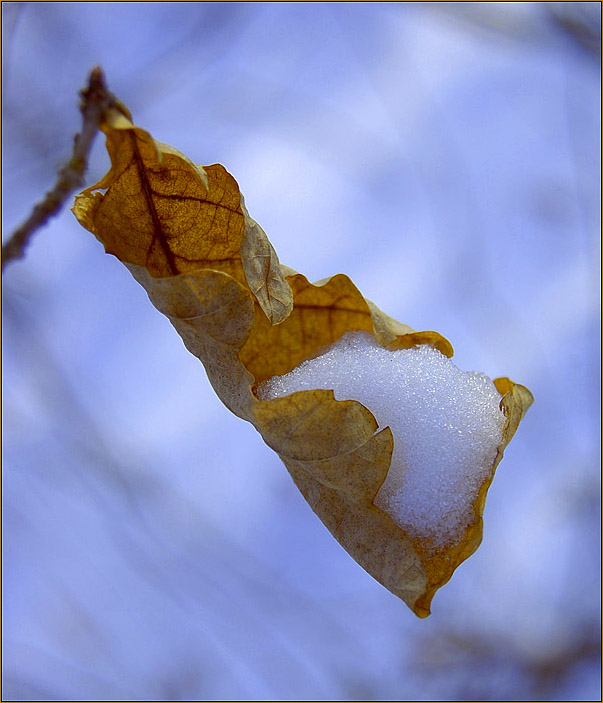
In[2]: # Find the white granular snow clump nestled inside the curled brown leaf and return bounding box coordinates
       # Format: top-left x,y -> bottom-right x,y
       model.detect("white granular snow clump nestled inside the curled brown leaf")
258,332 -> 505,548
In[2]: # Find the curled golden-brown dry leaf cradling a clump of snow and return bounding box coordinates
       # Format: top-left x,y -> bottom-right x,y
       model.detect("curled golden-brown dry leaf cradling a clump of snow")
73,111 -> 533,617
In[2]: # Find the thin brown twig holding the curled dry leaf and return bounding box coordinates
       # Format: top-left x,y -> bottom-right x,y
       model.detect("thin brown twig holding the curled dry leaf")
2,66 -> 125,270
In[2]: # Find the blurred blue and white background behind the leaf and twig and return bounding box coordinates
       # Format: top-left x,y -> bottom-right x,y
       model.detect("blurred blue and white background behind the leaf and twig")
2,2 -> 601,700
